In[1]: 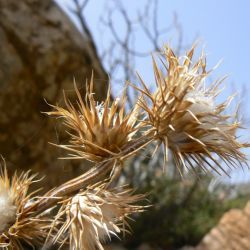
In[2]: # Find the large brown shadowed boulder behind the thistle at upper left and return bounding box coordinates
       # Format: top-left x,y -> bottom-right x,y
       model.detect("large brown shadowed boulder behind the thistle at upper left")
0,0 -> 107,189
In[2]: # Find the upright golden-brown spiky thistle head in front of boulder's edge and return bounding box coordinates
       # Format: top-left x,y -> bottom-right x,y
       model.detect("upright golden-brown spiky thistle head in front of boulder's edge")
48,77 -> 137,162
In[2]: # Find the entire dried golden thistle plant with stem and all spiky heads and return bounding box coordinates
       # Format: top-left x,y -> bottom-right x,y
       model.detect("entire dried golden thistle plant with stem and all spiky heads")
0,47 -> 248,250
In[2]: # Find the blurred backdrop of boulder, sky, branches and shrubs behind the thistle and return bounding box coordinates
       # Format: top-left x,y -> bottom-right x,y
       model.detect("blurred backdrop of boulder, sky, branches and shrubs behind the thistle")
0,0 -> 250,250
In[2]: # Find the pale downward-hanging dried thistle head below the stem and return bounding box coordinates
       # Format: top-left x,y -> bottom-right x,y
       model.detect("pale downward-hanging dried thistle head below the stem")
55,185 -> 145,250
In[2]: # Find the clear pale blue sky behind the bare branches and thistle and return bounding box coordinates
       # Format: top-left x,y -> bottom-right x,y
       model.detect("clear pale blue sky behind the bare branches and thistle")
57,0 -> 250,182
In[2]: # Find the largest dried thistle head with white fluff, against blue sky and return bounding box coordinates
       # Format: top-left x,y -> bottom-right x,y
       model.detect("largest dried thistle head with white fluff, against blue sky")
135,46 -> 247,176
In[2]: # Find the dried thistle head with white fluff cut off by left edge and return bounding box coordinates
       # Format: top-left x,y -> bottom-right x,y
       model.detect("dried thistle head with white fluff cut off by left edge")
0,164 -> 51,250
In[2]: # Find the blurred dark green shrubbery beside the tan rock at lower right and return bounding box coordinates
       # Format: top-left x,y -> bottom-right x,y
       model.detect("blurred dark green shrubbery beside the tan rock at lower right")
126,176 -> 250,250
